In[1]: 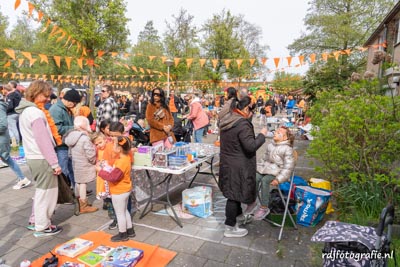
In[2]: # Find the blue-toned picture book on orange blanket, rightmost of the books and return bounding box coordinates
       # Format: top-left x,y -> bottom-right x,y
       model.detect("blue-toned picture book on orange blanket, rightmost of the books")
101,246 -> 144,267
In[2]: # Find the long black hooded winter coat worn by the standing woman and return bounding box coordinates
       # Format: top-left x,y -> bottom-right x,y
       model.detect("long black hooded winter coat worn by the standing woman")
219,118 -> 265,204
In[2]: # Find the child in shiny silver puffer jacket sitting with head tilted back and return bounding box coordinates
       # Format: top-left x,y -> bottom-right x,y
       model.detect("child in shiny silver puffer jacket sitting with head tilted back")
254,126 -> 295,220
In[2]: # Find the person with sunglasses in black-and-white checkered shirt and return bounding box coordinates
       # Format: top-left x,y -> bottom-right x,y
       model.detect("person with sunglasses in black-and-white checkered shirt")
96,84 -> 119,132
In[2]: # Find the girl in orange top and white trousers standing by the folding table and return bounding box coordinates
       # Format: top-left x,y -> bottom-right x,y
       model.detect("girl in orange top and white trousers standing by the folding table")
96,136 -> 136,242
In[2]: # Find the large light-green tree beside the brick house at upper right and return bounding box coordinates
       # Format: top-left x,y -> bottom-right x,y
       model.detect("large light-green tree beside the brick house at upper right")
288,0 -> 393,93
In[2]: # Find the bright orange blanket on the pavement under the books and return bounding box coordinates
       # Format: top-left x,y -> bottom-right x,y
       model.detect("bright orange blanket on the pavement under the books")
31,231 -> 176,267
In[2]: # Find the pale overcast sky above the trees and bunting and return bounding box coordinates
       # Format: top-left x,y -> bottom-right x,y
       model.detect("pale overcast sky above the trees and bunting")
0,0 -> 309,79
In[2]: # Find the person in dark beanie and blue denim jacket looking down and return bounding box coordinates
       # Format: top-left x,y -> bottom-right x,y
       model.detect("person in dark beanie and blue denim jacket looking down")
49,89 -> 81,188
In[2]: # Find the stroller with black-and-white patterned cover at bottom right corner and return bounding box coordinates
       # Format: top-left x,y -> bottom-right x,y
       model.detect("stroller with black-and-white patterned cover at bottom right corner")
311,205 -> 397,267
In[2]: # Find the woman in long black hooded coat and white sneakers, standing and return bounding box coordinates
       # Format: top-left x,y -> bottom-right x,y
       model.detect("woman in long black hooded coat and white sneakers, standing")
219,96 -> 268,237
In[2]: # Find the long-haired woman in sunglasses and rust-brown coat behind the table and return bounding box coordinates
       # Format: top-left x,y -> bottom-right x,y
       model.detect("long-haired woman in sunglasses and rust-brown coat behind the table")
146,87 -> 175,148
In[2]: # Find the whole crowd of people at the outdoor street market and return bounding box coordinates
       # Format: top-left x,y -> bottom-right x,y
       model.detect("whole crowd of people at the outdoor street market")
0,81 -> 305,242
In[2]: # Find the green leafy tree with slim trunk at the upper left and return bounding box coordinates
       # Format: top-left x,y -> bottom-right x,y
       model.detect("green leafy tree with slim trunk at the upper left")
34,0 -> 129,108
